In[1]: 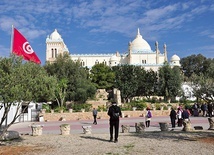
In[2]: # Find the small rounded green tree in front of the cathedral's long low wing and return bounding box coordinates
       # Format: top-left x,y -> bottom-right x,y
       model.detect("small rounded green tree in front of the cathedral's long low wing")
90,63 -> 115,90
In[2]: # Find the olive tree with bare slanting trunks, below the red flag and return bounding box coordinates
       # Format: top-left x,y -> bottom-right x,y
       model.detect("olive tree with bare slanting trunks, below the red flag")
0,56 -> 56,136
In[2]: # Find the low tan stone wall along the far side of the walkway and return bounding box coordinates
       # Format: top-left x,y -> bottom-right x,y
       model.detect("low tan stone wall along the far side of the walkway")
42,110 -> 170,121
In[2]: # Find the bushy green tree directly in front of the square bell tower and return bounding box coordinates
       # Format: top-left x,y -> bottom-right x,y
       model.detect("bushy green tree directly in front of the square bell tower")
44,54 -> 96,106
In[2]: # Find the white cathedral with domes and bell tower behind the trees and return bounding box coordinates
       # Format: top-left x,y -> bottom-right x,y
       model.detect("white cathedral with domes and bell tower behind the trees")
46,29 -> 180,71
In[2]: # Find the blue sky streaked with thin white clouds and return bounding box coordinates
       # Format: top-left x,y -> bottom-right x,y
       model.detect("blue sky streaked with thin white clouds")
0,0 -> 214,64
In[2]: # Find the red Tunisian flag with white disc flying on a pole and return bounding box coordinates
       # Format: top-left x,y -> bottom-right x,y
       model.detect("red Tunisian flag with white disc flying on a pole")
12,28 -> 41,64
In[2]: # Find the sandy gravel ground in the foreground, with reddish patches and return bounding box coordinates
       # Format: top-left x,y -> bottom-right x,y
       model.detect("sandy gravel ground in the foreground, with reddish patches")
0,131 -> 214,155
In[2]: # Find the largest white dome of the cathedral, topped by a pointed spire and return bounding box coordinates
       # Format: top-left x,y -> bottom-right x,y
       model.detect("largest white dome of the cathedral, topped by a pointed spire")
131,29 -> 151,51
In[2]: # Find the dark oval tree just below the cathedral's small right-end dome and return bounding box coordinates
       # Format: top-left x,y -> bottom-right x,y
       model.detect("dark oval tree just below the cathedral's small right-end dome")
158,63 -> 182,100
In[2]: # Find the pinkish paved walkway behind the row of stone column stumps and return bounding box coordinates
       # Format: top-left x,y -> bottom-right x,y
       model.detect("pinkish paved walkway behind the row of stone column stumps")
9,116 -> 209,134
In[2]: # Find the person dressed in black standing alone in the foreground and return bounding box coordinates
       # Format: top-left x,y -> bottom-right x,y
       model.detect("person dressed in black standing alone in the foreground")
108,102 -> 122,143
